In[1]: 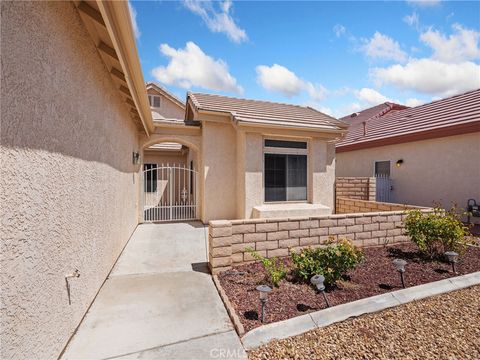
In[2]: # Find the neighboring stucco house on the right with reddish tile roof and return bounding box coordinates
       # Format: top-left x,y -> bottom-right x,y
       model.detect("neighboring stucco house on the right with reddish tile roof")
336,90 -> 480,215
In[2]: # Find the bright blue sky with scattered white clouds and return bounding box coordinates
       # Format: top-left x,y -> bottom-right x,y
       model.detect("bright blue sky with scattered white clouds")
130,0 -> 480,117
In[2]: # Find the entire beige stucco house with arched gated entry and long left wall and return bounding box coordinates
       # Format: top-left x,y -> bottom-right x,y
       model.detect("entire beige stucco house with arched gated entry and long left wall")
0,1 -> 347,358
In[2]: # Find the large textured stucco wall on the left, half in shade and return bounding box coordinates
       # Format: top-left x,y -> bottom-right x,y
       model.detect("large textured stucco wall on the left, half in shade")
0,2 -> 139,359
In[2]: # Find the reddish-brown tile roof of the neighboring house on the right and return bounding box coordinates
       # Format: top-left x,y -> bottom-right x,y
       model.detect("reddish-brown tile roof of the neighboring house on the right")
337,89 -> 480,152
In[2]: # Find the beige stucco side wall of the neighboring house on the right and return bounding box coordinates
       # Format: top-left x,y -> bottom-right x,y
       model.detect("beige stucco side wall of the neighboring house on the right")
337,132 -> 480,208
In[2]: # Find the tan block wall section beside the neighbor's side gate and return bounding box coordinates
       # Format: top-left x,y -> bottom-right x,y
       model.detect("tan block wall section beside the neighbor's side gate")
335,177 -> 376,201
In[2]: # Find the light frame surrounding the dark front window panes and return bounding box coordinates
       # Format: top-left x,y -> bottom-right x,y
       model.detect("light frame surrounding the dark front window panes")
262,136 -> 310,204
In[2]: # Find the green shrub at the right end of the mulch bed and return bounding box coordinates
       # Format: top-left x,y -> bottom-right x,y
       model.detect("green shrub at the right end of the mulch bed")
405,208 -> 468,257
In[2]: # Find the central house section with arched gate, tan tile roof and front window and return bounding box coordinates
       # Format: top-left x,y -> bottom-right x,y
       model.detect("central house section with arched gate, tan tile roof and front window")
144,93 -> 347,222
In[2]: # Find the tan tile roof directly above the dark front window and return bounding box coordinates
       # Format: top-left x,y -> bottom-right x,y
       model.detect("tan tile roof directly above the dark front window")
188,93 -> 348,131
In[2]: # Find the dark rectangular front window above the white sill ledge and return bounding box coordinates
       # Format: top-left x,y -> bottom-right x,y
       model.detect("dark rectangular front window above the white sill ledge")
264,140 -> 307,201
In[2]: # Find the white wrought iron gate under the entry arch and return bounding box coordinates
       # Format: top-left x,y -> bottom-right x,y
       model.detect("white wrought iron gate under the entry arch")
143,164 -> 198,222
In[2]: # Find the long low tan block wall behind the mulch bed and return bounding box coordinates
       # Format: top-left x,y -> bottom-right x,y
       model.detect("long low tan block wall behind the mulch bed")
208,209 -> 432,274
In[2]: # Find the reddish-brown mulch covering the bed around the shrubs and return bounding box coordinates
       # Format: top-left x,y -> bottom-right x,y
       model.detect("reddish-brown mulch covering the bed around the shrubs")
219,244 -> 480,331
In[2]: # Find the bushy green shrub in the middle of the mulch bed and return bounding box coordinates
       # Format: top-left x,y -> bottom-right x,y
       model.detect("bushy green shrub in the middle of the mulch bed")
292,240 -> 364,285
